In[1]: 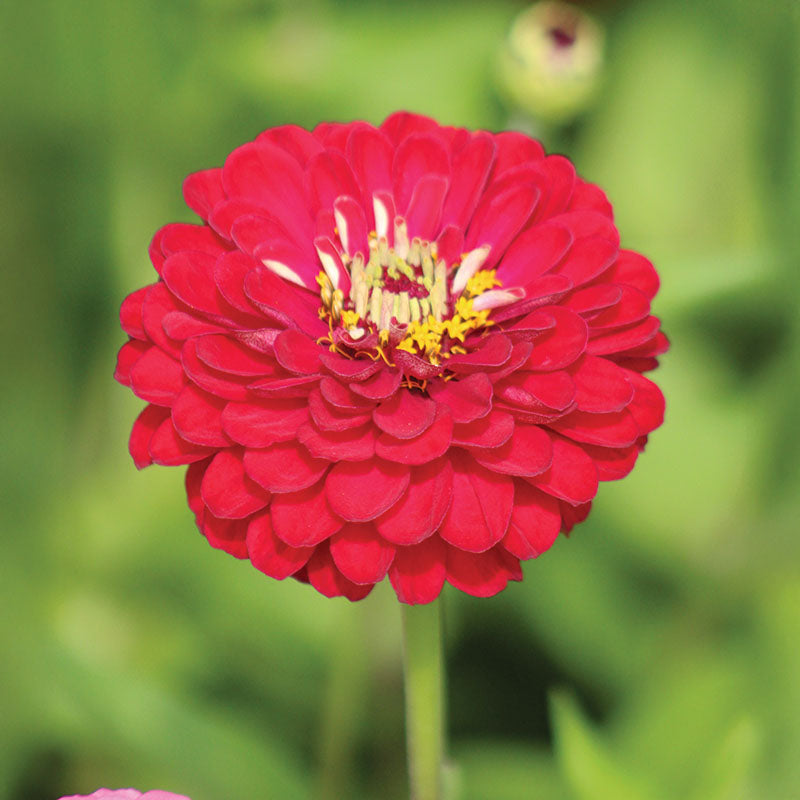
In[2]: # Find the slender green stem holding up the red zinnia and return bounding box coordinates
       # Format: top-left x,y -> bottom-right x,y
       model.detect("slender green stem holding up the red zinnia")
403,600 -> 445,800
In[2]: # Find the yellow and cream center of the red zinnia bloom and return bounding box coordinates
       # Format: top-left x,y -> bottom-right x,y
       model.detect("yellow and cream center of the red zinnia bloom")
317,217 -> 500,365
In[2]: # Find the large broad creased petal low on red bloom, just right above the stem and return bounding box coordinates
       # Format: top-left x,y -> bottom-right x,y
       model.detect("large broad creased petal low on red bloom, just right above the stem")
439,458 -> 514,553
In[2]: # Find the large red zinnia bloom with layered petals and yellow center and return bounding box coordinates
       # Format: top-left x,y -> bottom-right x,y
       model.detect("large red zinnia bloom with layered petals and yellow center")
116,113 -> 667,603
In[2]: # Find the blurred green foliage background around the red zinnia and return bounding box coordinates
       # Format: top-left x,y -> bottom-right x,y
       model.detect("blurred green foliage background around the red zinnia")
0,0 -> 800,800
